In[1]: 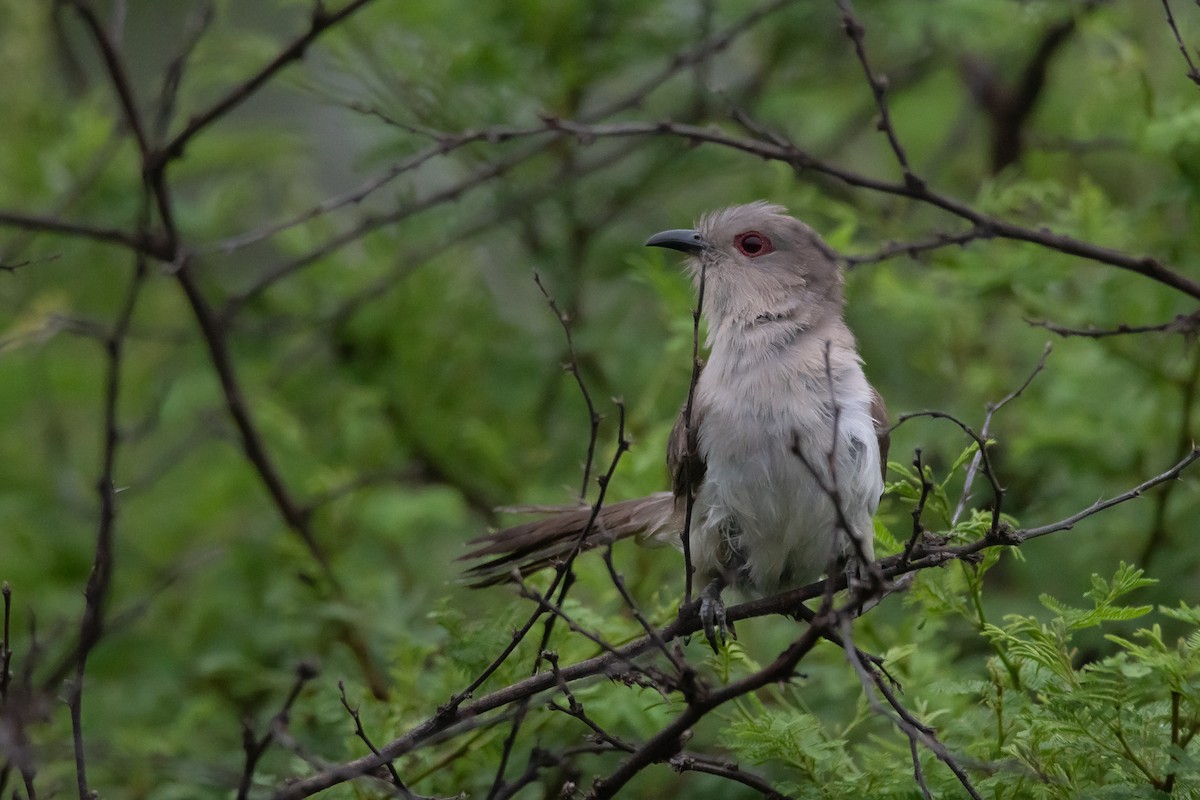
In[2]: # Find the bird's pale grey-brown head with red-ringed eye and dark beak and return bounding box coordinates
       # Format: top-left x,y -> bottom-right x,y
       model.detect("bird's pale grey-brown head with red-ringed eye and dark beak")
646,201 -> 844,327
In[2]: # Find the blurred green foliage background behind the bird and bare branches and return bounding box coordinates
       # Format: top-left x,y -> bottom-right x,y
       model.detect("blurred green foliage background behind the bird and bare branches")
0,0 -> 1200,798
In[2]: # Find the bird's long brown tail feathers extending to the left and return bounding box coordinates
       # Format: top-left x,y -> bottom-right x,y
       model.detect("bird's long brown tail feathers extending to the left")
461,492 -> 679,588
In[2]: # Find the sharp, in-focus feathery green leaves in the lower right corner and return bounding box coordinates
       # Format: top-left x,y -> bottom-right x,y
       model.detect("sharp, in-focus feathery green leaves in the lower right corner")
700,565 -> 1200,799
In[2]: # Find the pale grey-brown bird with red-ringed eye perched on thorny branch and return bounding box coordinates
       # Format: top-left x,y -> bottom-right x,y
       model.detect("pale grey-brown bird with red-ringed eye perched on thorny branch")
463,200 -> 889,650
